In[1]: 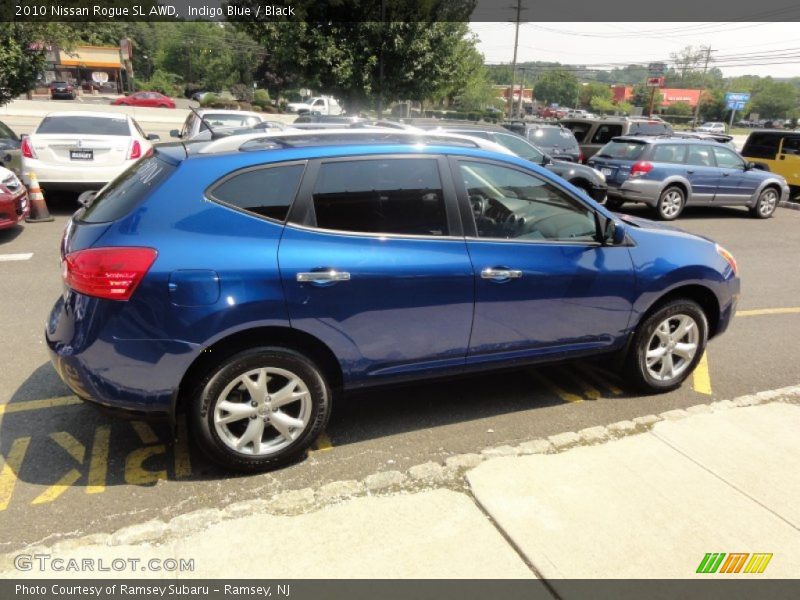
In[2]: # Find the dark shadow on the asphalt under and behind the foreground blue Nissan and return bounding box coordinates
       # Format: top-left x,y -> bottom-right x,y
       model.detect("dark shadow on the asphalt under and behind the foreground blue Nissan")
0,361 -> 630,487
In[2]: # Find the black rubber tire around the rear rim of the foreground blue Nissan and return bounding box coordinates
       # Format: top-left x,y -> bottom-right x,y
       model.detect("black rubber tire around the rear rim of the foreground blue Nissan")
188,347 -> 331,472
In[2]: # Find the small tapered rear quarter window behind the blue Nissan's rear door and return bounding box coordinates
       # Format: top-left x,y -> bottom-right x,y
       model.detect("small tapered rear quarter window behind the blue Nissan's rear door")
208,164 -> 305,221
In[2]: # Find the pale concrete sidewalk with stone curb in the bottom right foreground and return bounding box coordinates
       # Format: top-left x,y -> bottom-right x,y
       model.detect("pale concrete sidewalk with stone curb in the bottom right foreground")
0,386 -> 800,580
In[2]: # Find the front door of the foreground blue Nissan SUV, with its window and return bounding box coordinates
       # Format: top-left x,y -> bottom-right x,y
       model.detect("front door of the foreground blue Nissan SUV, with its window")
452,159 -> 635,363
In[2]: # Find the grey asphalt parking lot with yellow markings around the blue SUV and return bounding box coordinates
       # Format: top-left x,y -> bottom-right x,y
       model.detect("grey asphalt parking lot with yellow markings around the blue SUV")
0,195 -> 800,552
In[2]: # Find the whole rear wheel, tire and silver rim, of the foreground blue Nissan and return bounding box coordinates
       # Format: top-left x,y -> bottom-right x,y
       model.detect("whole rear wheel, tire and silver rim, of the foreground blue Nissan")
189,347 -> 331,472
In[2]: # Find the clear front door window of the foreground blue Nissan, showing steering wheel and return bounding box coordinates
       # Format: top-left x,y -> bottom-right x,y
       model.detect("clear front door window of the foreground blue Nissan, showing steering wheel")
459,161 -> 596,242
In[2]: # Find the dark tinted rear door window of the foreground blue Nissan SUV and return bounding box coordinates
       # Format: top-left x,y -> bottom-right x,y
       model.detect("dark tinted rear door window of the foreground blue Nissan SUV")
313,158 -> 448,236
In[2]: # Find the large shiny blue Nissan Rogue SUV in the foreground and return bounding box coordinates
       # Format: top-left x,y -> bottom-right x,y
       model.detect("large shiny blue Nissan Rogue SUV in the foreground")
46,130 -> 739,471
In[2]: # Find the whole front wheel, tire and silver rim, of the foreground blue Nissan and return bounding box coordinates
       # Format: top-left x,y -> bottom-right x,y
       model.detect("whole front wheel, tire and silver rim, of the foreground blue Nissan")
625,299 -> 708,393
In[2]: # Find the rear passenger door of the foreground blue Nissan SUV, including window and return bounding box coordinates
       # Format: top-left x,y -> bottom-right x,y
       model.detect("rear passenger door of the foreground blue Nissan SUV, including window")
279,155 -> 474,386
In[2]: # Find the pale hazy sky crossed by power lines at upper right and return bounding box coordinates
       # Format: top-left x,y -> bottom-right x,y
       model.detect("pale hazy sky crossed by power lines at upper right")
470,22 -> 800,77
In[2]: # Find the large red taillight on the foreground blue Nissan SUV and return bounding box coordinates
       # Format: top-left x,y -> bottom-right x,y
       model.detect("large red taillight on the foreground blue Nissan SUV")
61,247 -> 157,300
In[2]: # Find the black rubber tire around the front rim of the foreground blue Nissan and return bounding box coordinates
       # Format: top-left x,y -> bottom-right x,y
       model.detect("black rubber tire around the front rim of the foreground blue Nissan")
624,298 -> 708,393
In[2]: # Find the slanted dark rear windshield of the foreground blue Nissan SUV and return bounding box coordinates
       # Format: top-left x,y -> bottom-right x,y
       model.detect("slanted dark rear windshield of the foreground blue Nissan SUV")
80,156 -> 175,223
